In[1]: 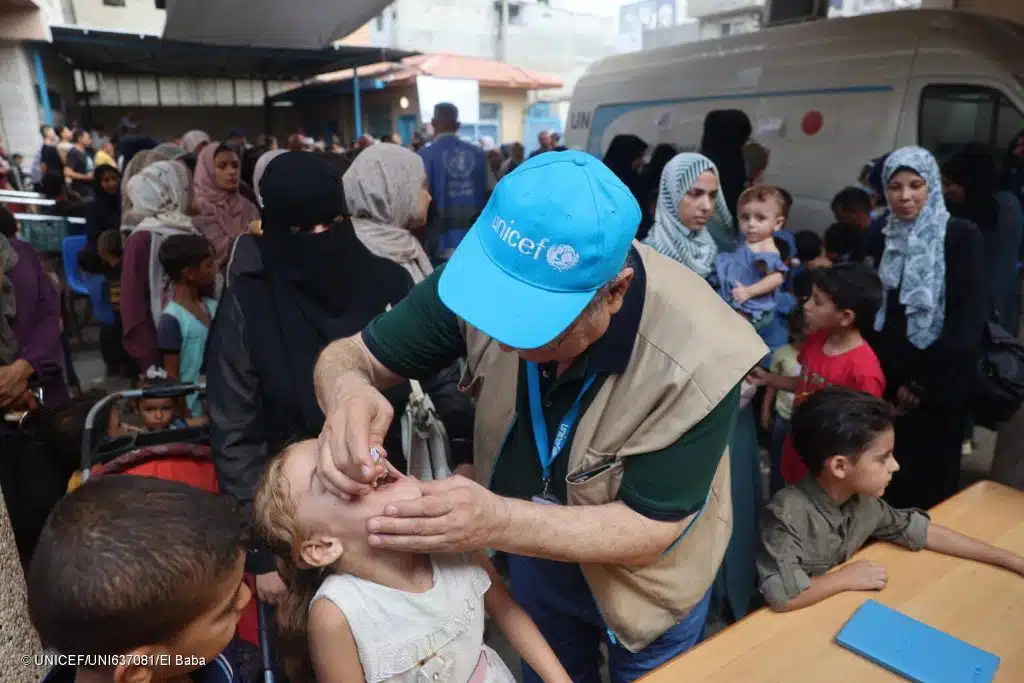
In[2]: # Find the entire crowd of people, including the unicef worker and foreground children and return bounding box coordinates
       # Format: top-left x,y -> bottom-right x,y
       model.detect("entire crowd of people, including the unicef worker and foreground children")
0,103 -> 1024,683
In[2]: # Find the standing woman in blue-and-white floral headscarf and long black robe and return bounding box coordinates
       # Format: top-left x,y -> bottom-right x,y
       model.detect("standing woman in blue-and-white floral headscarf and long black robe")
870,147 -> 987,510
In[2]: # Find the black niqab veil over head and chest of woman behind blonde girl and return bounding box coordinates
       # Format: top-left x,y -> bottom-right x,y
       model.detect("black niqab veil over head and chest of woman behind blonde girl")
253,153 -> 412,435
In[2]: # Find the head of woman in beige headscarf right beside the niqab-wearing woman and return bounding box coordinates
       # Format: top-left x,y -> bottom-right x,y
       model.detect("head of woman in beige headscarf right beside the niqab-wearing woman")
342,143 -> 433,283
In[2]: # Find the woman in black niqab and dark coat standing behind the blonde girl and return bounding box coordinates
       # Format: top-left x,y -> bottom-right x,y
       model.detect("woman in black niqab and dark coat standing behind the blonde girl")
206,152 -> 412,557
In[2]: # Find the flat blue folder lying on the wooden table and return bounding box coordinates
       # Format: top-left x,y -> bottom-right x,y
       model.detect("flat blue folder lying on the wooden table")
836,600 -> 999,683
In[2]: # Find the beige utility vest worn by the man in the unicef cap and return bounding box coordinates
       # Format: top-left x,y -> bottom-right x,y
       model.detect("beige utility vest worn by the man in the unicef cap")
462,244 -> 768,652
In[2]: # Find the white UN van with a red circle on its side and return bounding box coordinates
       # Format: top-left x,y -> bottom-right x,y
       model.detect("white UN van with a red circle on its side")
565,8 -> 1024,231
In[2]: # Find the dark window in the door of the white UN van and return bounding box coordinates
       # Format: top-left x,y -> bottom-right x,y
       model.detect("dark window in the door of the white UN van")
918,85 -> 1024,163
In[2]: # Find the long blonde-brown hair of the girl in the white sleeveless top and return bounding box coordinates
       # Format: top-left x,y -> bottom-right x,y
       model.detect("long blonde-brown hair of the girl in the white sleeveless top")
253,449 -> 326,681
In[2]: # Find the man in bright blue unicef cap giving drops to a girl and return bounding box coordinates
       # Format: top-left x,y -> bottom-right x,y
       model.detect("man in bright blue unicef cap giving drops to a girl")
315,152 -> 766,683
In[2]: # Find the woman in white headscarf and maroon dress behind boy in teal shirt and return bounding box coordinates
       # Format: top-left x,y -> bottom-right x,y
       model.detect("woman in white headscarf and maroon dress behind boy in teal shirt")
121,161 -> 197,370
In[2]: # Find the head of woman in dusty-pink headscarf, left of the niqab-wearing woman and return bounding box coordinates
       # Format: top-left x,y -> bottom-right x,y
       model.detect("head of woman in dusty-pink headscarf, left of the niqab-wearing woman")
193,142 -> 259,267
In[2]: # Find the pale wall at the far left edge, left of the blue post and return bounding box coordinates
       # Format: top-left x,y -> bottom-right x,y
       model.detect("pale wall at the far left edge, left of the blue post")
0,42 -> 41,163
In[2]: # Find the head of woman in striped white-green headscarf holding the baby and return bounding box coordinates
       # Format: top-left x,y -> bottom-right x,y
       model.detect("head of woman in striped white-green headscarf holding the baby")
644,153 -> 732,278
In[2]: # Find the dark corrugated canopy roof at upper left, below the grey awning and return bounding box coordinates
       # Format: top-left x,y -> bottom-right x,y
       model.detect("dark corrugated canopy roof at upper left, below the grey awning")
39,26 -> 415,81
